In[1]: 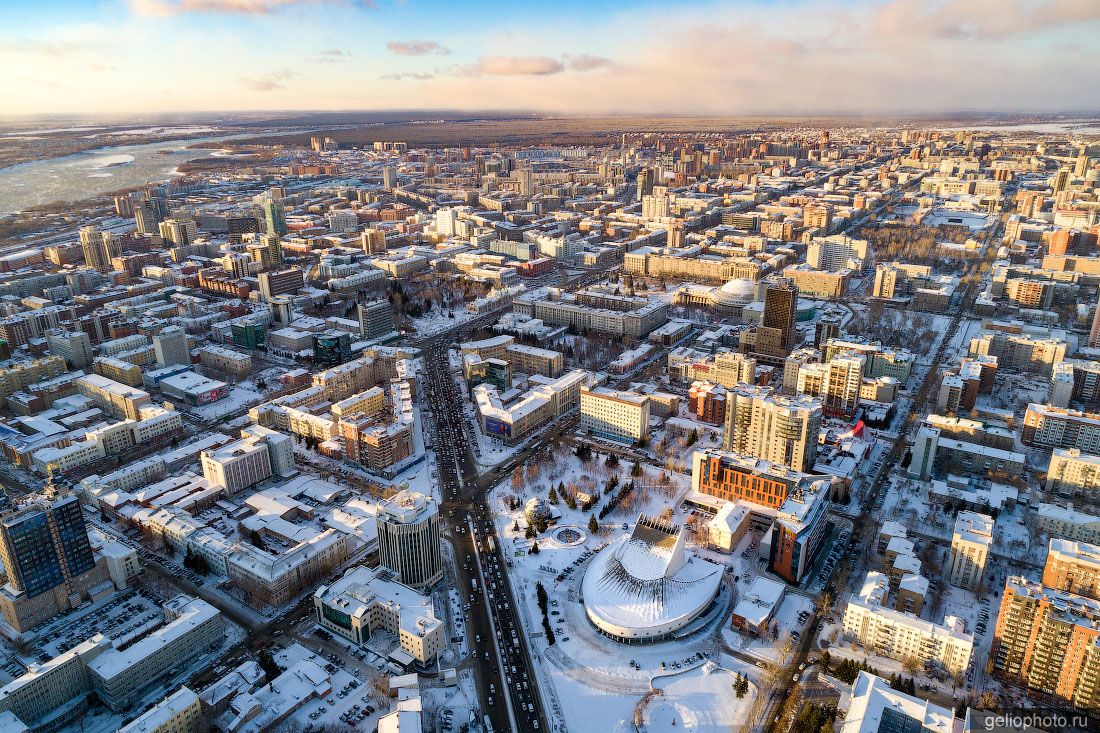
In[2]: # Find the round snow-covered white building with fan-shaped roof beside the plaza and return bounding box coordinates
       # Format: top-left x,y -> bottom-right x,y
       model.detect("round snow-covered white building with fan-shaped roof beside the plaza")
581,515 -> 722,644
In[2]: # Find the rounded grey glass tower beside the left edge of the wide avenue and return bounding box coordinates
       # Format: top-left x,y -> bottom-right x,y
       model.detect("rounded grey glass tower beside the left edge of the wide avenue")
377,489 -> 443,590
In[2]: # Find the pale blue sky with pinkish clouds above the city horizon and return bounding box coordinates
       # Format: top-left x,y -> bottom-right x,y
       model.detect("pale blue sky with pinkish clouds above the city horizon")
0,0 -> 1100,114
